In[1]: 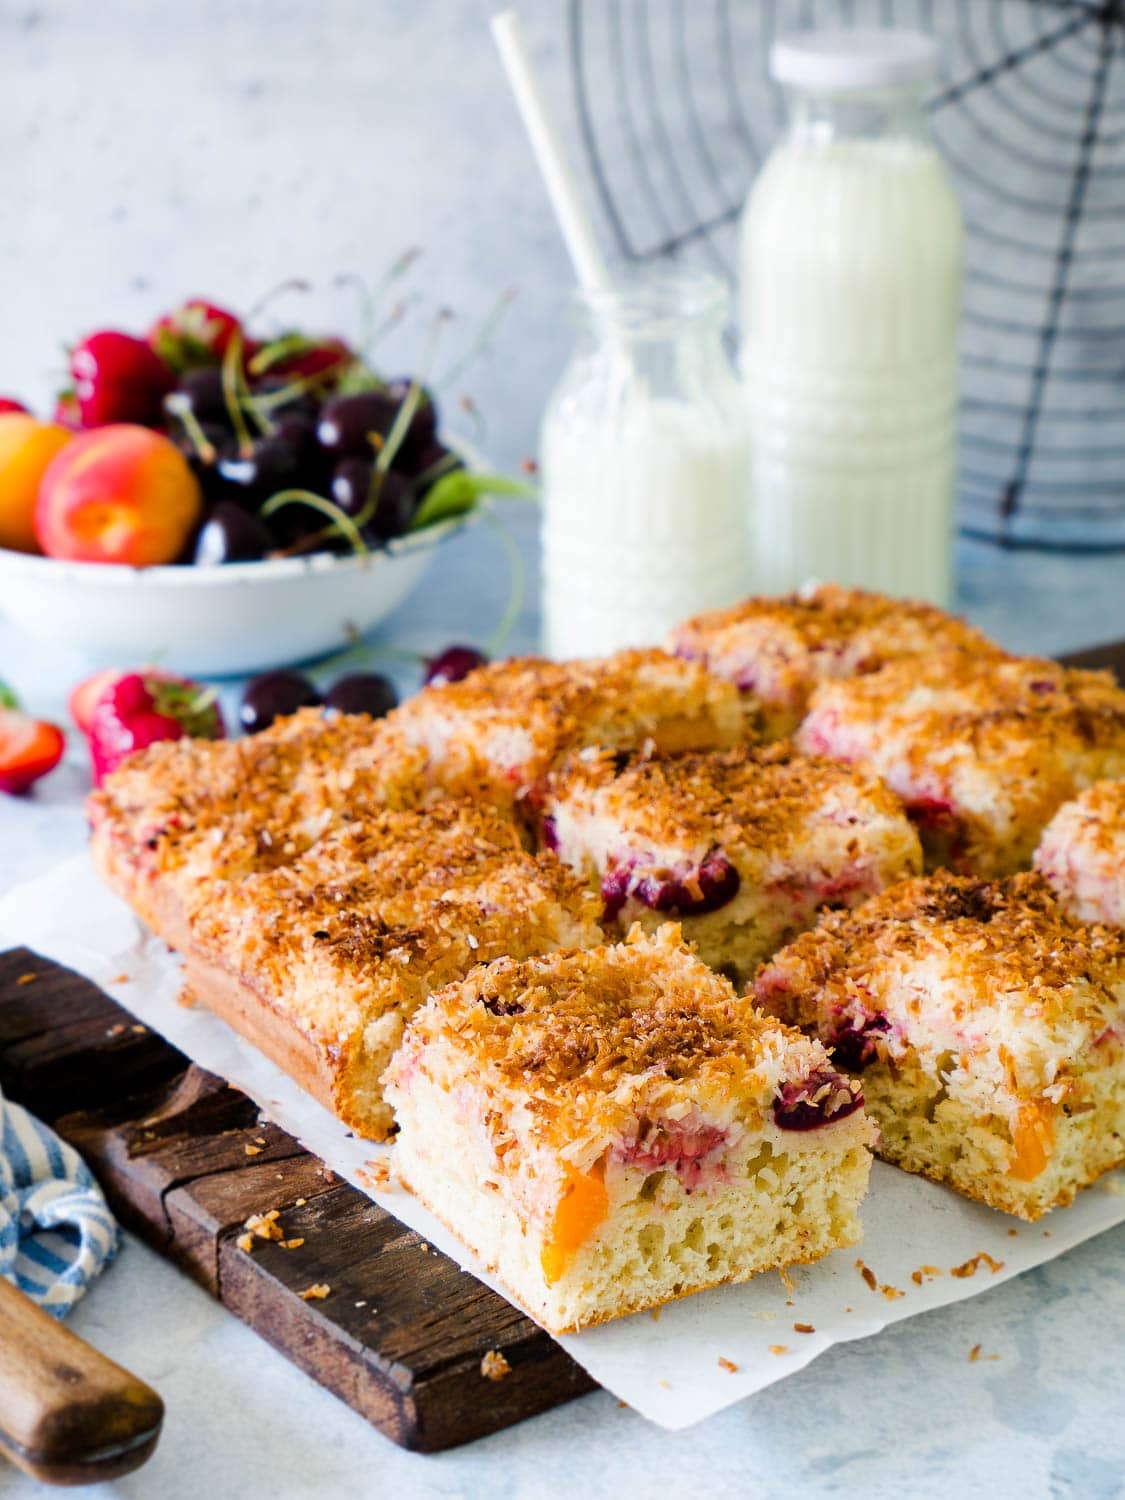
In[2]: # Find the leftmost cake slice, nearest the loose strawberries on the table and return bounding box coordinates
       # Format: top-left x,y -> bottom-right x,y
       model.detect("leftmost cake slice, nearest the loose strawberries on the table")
86,710 -> 425,948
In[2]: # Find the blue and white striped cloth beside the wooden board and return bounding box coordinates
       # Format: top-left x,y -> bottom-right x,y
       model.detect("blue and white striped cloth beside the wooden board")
0,1094 -> 117,1317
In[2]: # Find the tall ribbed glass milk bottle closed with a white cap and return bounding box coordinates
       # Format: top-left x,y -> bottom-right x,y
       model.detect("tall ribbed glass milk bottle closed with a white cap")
740,30 -> 963,605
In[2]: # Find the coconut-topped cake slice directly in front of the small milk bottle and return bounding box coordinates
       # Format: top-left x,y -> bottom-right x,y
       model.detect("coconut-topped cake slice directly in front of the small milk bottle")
389,651 -> 749,821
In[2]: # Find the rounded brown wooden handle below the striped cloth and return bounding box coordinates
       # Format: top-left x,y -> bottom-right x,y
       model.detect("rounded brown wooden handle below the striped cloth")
0,1277 -> 164,1485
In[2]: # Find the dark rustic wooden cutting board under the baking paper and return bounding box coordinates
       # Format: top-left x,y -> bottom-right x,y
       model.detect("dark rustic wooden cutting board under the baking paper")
0,642 -> 1125,1452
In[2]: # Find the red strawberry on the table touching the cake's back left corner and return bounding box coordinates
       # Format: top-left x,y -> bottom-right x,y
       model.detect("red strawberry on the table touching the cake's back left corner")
87,671 -> 227,786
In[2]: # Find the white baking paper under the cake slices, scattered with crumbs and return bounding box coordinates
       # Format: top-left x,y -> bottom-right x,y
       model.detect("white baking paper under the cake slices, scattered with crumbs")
0,855 -> 1125,1428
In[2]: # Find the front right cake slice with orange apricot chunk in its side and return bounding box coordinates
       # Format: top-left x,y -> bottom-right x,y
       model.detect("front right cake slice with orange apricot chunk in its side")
755,872 -> 1125,1220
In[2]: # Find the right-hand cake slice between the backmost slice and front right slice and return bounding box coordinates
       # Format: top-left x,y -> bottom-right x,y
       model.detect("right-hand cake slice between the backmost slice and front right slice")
797,651 -> 1125,878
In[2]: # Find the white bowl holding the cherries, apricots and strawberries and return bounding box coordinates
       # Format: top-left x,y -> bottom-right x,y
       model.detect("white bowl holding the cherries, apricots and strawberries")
0,518 -> 465,677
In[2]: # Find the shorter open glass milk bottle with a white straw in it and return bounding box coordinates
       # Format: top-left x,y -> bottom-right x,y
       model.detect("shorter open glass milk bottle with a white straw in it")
542,275 -> 749,659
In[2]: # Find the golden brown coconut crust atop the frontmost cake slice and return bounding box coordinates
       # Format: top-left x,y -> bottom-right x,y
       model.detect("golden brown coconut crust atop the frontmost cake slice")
392,924 -> 831,1146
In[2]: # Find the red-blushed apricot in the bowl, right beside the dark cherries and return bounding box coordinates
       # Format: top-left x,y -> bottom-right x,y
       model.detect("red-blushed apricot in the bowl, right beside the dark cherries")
35,422 -> 203,567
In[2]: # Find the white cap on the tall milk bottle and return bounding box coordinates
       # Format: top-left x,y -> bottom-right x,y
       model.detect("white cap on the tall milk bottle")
770,27 -> 938,93
